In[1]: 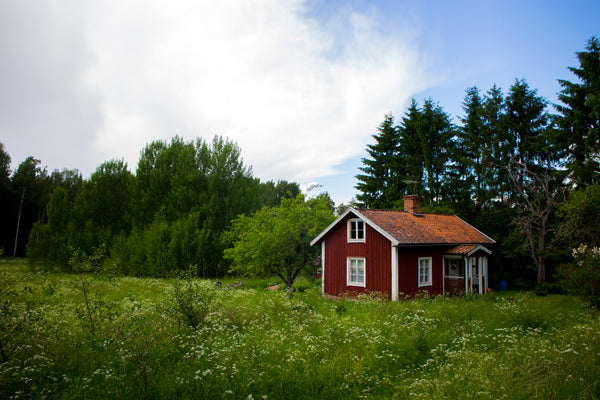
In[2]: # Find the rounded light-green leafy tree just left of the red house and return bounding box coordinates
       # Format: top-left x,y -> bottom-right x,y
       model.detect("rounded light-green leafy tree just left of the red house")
224,195 -> 334,290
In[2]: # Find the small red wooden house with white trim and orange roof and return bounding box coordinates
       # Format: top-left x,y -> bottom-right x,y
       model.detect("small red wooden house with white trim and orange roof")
311,196 -> 495,300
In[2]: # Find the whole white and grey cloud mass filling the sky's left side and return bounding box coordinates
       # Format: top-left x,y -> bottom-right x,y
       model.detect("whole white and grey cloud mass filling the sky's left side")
0,0 -> 433,189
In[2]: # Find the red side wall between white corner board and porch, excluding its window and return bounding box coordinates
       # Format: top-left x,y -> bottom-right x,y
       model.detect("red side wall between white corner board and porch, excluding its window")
398,247 -> 444,296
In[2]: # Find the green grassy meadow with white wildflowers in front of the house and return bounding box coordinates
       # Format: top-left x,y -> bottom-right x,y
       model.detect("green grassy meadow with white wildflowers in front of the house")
0,260 -> 600,399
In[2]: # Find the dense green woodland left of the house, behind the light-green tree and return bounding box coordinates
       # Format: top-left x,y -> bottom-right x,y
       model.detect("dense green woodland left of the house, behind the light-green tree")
0,136 -> 310,277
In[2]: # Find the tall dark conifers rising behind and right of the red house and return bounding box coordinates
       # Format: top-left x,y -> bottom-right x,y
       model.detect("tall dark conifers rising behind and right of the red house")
356,37 -> 600,283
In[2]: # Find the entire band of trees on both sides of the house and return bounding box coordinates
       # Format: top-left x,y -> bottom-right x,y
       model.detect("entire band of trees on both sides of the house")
0,37 -> 600,287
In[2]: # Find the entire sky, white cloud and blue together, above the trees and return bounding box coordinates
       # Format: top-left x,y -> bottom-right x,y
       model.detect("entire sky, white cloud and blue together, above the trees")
0,0 -> 600,204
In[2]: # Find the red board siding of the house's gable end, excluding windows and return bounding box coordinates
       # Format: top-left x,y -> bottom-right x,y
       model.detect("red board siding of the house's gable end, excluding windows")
324,216 -> 392,296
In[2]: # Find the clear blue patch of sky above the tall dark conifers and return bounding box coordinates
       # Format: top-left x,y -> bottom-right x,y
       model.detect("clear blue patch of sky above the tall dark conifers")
312,1 -> 600,205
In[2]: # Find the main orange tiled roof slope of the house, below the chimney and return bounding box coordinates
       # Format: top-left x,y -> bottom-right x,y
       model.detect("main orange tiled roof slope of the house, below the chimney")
356,210 -> 495,245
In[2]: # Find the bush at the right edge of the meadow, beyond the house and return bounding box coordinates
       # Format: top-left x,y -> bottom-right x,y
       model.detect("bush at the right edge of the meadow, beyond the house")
557,245 -> 600,309
